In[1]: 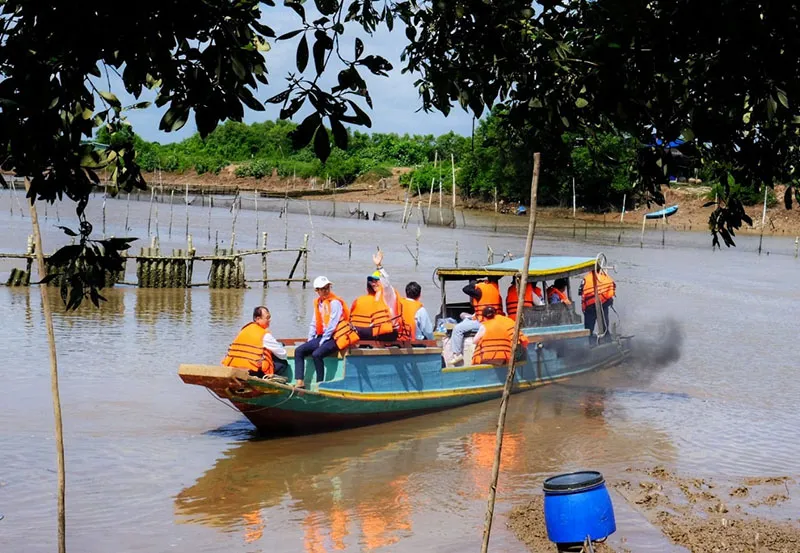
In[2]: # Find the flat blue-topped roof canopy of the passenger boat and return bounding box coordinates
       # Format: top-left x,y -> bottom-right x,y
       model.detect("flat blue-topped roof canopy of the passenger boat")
436,256 -> 596,280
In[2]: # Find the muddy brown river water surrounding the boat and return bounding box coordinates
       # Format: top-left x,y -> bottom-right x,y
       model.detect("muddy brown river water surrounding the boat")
0,191 -> 800,553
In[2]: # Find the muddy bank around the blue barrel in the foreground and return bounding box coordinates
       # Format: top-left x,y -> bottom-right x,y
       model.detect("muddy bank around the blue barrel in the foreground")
508,466 -> 800,553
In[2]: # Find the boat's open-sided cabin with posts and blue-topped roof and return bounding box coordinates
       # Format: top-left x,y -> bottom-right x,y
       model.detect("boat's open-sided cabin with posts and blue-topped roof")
434,256 -> 597,328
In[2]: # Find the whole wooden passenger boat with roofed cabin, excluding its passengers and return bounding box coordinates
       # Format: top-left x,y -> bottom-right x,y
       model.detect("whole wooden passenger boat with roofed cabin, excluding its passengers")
178,257 -> 628,434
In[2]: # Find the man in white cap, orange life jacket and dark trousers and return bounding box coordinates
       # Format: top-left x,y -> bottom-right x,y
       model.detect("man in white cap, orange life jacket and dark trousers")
294,276 -> 358,388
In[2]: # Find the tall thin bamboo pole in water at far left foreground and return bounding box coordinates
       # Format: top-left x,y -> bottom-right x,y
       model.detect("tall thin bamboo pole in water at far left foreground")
25,178 -> 67,553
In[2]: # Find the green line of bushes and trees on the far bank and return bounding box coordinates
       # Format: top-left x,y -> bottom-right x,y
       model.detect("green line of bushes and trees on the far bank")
114,107 -> 774,211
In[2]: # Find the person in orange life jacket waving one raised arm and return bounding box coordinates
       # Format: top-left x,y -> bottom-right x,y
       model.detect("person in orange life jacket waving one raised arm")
350,250 -> 401,341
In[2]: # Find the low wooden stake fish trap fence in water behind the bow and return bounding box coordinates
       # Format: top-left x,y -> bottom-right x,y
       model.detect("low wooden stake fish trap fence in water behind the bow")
0,233 -> 309,289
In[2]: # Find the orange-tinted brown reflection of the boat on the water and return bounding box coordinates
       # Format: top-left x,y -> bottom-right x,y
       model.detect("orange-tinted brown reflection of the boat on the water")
175,387 -> 674,553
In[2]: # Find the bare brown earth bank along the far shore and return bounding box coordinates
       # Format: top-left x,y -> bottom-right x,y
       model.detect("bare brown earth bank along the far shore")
145,165 -> 800,236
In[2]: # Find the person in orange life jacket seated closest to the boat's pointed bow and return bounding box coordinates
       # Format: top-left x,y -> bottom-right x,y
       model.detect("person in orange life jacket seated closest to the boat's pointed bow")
222,305 -> 289,377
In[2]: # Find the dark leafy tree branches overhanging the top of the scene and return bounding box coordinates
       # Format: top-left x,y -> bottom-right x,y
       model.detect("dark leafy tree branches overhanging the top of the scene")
0,0 -> 800,302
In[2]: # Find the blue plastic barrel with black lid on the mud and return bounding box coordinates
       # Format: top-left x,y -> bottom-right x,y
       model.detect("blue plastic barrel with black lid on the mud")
543,471 -> 617,544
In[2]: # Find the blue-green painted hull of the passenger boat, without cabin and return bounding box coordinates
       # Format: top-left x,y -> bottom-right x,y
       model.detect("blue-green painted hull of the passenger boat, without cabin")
181,330 -> 628,435
